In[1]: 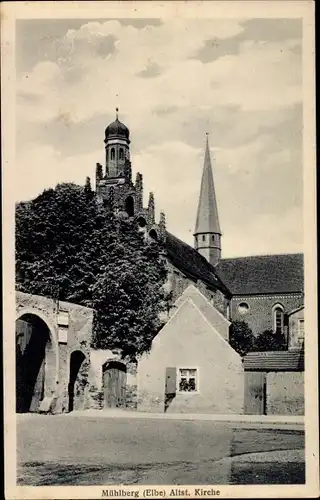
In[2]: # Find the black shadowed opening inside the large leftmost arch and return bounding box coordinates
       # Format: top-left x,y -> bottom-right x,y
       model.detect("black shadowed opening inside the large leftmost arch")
16,314 -> 51,413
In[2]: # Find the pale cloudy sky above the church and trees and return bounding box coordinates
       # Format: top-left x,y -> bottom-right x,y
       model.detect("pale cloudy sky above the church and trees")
15,18 -> 303,257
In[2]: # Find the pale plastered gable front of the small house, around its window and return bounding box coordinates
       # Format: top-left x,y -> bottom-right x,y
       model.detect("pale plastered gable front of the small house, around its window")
138,299 -> 244,414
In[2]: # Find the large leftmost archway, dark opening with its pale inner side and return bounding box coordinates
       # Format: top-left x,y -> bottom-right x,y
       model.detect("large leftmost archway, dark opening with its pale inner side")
16,310 -> 58,413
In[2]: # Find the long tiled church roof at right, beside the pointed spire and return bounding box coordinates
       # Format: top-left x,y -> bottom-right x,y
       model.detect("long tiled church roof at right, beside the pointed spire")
215,253 -> 304,295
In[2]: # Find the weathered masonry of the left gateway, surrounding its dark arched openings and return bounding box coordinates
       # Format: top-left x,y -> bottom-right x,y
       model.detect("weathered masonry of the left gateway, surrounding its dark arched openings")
16,292 -> 93,413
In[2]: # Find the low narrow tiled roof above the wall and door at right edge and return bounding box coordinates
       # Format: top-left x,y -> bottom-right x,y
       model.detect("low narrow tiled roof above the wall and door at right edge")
243,350 -> 304,372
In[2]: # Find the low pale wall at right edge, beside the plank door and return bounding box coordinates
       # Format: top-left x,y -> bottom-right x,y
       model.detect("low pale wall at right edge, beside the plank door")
267,372 -> 304,415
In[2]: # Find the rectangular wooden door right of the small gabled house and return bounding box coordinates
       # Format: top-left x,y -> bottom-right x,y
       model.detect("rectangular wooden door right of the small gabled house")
244,372 -> 267,415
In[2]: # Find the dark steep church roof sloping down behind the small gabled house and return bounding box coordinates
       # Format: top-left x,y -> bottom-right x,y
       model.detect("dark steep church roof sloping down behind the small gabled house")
166,232 -> 230,296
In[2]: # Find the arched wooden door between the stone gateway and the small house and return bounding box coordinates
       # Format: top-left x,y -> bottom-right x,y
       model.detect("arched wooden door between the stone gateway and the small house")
102,361 -> 127,408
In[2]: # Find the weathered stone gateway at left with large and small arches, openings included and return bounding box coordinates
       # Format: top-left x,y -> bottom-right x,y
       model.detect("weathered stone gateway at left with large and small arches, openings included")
12,291 -> 93,413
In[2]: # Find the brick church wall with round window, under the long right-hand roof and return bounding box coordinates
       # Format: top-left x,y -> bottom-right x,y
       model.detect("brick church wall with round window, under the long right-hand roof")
230,294 -> 303,335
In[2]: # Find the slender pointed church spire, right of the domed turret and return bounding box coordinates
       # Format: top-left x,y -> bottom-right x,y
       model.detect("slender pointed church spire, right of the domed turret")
194,134 -> 221,266
